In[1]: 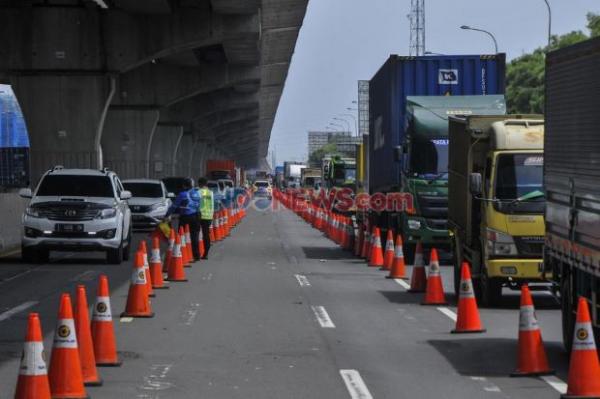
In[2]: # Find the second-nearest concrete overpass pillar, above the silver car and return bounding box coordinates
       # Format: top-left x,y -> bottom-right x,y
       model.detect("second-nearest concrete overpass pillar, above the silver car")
102,109 -> 160,179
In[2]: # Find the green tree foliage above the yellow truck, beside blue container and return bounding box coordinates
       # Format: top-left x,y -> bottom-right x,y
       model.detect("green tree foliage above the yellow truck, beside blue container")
506,13 -> 600,114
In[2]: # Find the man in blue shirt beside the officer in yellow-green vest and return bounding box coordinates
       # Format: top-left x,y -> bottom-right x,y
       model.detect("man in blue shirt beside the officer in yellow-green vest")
167,179 -> 200,261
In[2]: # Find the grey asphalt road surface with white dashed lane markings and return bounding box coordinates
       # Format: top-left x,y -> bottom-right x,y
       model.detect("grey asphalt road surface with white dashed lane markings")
0,205 -> 568,399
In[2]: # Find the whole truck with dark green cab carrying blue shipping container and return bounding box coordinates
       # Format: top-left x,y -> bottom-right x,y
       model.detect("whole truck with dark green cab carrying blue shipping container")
368,54 -> 505,263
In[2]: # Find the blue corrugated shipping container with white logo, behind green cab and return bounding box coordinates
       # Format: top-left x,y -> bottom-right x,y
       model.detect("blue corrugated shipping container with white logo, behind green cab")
369,54 -> 505,193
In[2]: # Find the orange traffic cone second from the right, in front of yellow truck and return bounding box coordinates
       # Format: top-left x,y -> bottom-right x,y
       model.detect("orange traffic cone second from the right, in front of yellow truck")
510,284 -> 554,377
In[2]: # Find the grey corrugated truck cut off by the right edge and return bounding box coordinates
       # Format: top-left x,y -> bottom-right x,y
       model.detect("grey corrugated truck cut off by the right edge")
544,38 -> 600,349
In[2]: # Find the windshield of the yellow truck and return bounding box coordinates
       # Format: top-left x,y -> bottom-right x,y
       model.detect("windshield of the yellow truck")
494,154 -> 545,212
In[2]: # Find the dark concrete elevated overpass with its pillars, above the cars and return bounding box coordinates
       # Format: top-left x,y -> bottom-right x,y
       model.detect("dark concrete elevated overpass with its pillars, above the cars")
0,0 -> 308,183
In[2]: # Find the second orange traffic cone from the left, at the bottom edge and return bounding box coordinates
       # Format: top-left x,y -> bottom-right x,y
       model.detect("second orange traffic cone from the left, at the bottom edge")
48,294 -> 88,399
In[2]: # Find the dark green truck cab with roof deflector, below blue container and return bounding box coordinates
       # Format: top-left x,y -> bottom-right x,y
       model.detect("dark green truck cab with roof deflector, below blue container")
390,95 -> 506,263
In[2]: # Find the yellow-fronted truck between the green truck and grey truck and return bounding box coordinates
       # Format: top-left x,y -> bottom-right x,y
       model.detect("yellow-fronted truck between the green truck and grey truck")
448,115 -> 548,306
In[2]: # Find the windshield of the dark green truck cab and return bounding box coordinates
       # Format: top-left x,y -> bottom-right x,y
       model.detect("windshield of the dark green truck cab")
410,138 -> 448,180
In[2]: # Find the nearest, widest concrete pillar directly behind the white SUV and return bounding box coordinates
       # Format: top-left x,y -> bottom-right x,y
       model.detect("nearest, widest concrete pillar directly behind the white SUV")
11,75 -> 115,184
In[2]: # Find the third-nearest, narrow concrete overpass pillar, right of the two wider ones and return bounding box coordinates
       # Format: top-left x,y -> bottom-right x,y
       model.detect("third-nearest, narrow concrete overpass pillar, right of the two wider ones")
150,124 -> 183,179
